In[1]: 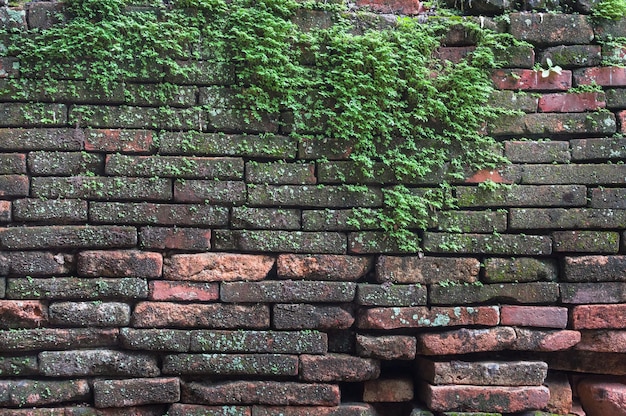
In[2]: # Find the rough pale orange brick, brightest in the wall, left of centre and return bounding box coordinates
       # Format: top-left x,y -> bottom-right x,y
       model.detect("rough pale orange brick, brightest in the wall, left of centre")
163,253 -> 275,282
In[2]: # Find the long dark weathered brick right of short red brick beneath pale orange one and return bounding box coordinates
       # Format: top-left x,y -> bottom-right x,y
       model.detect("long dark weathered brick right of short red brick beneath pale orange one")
220,280 -> 356,303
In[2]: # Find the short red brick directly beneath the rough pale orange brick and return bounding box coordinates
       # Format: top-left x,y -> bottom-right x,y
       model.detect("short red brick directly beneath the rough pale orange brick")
148,280 -> 220,302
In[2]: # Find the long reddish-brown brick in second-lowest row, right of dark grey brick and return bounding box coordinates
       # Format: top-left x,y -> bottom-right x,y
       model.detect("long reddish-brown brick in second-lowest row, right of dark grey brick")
181,381 -> 339,406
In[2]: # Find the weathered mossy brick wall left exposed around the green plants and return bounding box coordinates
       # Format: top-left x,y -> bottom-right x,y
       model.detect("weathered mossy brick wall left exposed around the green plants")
0,0 -> 626,416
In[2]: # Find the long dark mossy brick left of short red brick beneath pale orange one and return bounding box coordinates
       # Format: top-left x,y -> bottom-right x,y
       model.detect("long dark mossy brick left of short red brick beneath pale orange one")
6,277 -> 148,300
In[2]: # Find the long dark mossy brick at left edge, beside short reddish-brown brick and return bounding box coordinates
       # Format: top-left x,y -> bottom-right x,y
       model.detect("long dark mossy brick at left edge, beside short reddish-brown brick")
0,225 -> 137,250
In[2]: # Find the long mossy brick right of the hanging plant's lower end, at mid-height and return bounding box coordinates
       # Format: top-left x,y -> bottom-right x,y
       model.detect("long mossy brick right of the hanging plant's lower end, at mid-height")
456,184 -> 587,208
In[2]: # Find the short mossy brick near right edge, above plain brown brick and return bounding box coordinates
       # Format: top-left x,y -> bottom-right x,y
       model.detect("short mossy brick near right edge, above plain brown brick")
552,231 -> 619,254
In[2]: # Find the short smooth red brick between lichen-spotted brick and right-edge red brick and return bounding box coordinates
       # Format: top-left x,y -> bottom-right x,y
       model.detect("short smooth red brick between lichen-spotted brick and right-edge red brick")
500,305 -> 568,329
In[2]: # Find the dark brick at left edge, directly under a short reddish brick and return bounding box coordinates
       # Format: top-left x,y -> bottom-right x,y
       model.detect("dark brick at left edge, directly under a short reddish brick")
0,328 -> 118,352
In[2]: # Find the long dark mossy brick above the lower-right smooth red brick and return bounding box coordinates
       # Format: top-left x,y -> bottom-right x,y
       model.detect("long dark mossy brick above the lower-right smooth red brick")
428,282 -> 559,305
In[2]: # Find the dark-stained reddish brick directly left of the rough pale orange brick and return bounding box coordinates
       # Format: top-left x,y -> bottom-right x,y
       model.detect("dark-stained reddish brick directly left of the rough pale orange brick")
77,250 -> 163,278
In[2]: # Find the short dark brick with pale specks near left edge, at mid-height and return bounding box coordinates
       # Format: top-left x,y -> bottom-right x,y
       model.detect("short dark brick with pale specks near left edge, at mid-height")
13,198 -> 88,224
